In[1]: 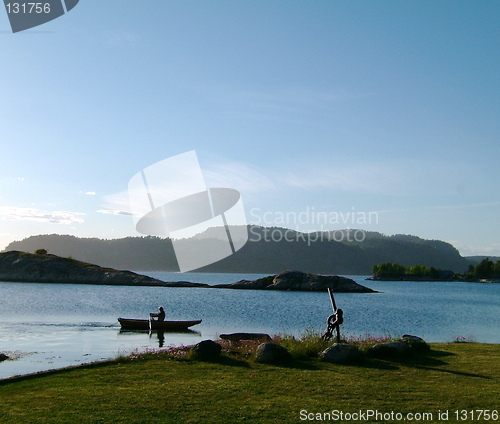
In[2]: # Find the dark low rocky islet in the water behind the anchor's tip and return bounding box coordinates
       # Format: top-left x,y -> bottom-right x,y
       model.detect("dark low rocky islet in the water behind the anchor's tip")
214,271 -> 376,293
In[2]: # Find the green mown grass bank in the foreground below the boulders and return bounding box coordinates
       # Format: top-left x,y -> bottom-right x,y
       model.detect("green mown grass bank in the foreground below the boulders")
0,343 -> 500,424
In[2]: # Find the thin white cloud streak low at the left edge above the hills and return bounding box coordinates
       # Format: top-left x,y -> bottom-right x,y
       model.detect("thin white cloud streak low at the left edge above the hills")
0,206 -> 85,225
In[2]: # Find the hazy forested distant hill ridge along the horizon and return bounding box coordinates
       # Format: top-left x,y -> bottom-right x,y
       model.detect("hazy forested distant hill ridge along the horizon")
5,226 -> 470,275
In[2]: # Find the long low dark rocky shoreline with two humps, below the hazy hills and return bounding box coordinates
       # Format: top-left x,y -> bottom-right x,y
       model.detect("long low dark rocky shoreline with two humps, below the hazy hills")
0,251 -> 375,293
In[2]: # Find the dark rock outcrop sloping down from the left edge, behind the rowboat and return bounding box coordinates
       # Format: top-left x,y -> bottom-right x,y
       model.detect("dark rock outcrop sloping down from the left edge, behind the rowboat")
0,251 -> 208,287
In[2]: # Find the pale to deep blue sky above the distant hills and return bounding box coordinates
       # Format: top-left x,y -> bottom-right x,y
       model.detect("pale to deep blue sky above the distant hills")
0,0 -> 500,255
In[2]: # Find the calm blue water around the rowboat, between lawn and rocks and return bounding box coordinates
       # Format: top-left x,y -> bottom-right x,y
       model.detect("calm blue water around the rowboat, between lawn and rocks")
0,273 -> 500,378
